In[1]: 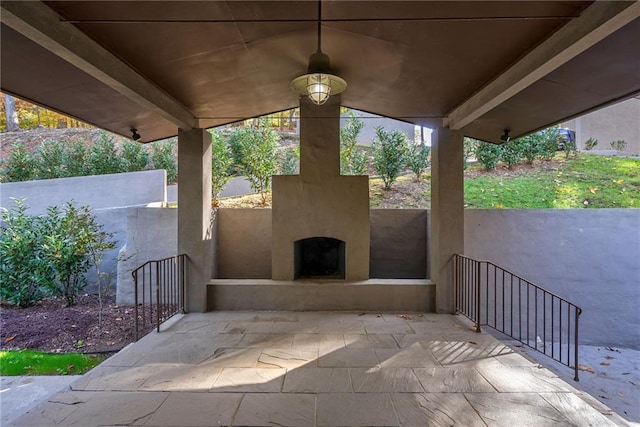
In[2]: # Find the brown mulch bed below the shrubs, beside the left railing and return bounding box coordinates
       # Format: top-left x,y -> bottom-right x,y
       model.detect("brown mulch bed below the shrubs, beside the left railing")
0,295 -> 135,353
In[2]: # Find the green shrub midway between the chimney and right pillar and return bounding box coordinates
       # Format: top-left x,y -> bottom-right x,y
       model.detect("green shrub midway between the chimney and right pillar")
373,126 -> 409,190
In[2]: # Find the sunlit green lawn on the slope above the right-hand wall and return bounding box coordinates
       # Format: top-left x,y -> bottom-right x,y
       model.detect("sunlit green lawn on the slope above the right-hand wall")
464,154 -> 640,209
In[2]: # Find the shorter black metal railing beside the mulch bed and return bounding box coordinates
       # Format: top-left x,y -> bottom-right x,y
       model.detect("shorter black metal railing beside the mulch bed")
131,255 -> 187,341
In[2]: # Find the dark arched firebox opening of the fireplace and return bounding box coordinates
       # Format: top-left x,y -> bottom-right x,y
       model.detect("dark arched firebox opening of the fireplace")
293,237 -> 345,279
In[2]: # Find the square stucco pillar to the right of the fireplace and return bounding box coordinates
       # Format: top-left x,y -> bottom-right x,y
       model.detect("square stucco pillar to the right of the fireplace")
429,128 -> 464,313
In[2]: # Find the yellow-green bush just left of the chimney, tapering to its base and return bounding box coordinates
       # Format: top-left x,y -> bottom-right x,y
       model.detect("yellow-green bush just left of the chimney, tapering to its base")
230,122 -> 280,204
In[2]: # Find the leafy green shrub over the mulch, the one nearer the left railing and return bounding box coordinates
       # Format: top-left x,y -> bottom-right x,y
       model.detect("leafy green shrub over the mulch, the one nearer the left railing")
41,202 -> 115,306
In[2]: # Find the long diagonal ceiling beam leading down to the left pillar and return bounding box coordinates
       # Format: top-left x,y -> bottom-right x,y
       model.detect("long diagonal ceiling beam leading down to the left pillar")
0,0 -> 196,130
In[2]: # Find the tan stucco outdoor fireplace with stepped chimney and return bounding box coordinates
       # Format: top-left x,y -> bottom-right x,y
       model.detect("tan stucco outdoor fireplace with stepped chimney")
271,96 -> 370,281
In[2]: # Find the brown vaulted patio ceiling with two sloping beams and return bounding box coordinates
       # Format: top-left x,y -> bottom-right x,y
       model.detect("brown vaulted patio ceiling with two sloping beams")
0,0 -> 640,142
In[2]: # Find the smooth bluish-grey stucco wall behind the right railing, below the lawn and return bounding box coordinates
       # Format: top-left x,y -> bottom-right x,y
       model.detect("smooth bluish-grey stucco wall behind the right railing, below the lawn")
465,209 -> 640,349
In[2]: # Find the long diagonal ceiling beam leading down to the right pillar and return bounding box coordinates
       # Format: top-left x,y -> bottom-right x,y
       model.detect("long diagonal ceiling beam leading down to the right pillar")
443,1 -> 640,130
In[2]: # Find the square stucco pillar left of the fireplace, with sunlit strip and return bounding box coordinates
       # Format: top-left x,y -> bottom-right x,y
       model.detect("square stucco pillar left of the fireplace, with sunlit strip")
178,129 -> 213,312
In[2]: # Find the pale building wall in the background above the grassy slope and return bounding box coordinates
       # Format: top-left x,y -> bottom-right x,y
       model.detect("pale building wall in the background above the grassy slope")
561,97 -> 640,155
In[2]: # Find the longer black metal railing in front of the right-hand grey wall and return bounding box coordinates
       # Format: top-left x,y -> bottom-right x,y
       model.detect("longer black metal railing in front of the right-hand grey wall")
453,254 -> 582,381
